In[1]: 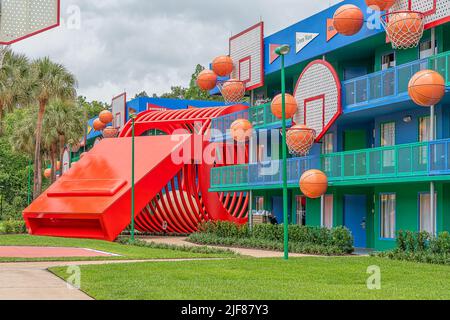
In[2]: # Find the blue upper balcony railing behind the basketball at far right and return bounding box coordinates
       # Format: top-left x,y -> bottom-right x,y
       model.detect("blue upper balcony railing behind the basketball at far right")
342,52 -> 450,113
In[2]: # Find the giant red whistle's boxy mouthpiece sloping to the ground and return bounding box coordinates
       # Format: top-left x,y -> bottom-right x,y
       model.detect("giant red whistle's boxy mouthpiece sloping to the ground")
23,135 -> 191,241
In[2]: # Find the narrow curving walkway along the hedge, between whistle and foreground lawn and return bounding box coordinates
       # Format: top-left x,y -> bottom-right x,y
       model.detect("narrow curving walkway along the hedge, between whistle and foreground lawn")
140,237 -> 317,258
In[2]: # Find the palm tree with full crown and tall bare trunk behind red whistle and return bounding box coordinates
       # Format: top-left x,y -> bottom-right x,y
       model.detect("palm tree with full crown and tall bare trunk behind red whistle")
30,58 -> 77,199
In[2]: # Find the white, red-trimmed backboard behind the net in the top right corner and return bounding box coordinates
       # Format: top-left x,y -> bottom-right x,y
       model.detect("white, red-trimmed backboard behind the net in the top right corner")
390,0 -> 450,29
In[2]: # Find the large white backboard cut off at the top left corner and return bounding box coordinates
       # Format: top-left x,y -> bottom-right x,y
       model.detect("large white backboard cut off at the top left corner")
0,0 -> 61,45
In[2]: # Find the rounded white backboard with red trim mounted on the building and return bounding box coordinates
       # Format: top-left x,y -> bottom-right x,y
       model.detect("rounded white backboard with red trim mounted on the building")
293,60 -> 342,141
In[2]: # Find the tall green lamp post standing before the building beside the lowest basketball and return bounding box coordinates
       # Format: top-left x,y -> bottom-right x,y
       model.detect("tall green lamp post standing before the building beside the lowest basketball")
275,45 -> 291,260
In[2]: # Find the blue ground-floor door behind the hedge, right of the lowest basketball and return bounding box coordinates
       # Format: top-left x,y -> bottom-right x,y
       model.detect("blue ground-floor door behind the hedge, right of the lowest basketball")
344,195 -> 367,248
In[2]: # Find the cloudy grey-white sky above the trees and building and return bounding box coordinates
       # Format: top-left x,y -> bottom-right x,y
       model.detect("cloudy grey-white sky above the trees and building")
12,0 -> 340,102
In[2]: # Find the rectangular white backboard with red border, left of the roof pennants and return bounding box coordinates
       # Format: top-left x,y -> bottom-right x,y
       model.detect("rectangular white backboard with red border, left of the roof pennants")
230,22 -> 264,91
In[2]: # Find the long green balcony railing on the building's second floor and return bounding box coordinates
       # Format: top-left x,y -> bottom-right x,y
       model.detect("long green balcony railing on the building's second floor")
211,139 -> 450,191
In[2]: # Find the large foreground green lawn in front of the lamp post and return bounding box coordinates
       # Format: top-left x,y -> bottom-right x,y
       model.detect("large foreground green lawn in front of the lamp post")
51,257 -> 450,300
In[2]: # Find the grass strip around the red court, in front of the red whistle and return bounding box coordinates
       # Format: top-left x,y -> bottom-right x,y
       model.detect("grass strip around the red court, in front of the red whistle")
0,235 -> 235,262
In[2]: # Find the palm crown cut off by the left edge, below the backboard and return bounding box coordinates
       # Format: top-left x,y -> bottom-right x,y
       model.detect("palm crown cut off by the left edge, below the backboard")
0,50 -> 29,135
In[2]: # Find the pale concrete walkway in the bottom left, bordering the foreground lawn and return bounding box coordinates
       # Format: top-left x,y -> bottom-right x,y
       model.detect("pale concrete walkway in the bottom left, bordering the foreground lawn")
0,258 -> 229,300
